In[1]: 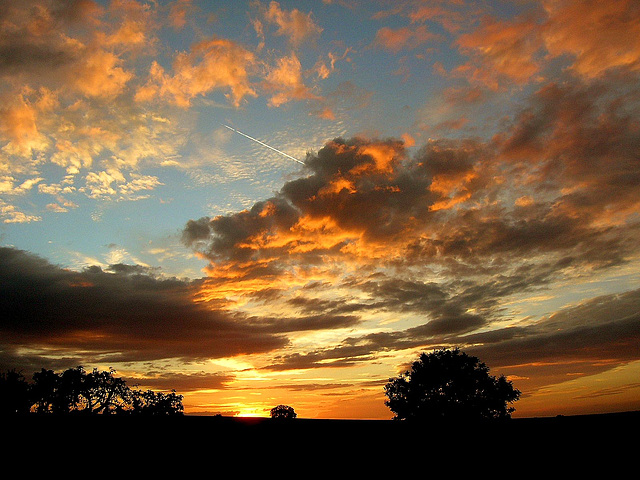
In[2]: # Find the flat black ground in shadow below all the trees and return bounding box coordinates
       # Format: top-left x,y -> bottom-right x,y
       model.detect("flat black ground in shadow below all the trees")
0,412 -> 640,470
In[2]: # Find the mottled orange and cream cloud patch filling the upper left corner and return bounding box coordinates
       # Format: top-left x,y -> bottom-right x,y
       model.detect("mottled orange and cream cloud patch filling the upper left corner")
0,0 -> 186,204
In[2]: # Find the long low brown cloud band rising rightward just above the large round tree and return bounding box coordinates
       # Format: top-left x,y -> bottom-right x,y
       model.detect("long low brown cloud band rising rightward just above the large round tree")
267,290 -> 640,376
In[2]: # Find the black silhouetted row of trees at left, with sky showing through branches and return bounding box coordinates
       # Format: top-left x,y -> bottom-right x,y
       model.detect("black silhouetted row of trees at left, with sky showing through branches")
0,367 -> 184,415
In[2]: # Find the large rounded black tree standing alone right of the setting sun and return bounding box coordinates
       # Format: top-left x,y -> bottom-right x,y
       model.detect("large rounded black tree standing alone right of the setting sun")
385,348 -> 520,421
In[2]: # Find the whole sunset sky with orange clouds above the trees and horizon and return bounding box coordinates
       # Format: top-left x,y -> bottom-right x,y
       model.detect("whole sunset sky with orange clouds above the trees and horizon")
0,0 -> 640,419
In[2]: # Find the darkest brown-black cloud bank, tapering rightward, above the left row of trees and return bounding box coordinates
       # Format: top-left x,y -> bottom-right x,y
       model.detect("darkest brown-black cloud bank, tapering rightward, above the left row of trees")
0,248 -> 288,367
